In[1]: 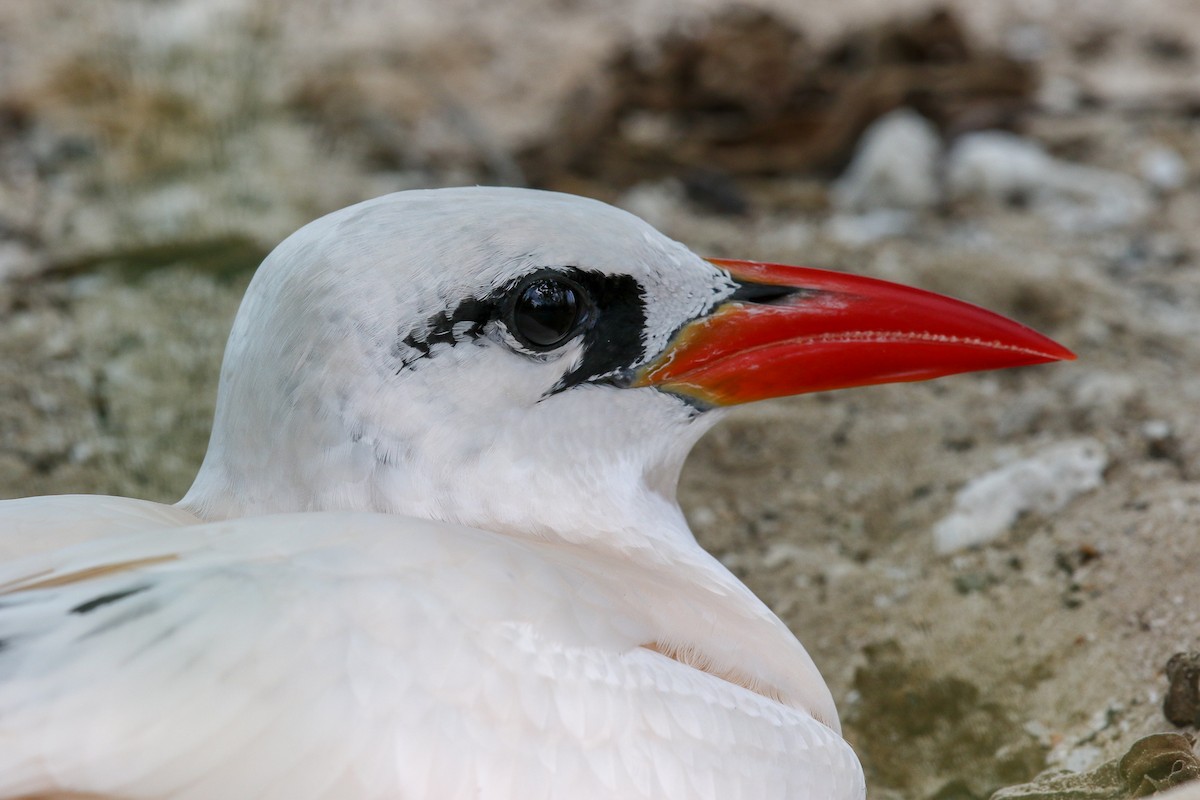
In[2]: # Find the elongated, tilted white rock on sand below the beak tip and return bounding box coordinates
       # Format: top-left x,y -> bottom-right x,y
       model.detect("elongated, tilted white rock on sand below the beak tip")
934,439 -> 1109,553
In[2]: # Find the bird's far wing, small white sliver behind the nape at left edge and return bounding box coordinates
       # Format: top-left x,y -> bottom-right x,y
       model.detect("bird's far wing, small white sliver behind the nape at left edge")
0,494 -> 200,564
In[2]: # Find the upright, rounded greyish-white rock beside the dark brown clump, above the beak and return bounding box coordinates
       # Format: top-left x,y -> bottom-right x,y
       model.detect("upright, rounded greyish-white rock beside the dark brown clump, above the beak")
833,108 -> 942,211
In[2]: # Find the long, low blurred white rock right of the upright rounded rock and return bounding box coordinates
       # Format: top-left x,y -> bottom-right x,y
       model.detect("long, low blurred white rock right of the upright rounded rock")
946,131 -> 1151,231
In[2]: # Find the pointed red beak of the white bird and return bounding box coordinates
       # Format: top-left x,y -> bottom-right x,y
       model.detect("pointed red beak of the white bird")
634,259 -> 1075,405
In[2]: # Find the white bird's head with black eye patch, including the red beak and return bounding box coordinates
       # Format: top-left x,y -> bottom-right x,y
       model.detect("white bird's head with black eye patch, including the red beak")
181,188 -> 1073,551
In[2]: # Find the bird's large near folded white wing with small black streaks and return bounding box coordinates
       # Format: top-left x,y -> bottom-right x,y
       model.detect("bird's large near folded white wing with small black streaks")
0,513 -> 864,800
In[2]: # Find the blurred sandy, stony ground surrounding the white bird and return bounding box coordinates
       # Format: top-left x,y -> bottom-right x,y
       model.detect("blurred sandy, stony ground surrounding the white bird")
0,0 -> 1200,800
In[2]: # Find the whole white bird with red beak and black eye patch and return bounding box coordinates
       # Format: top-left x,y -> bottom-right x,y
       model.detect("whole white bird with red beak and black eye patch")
0,187 -> 1074,800
